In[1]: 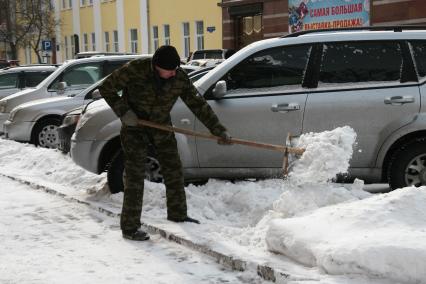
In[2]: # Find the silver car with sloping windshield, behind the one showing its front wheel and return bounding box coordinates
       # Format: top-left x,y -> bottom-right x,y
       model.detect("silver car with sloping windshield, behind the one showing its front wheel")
0,55 -> 150,132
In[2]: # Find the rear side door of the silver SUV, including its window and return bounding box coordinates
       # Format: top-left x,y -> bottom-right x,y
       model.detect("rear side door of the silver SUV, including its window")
303,41 -> 420,168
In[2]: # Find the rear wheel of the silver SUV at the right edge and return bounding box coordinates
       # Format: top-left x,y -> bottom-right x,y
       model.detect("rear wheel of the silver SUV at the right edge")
387,138 -> 426,189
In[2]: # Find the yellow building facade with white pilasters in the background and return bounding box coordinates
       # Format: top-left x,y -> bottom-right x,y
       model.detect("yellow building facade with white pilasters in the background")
19,0 -> 222,63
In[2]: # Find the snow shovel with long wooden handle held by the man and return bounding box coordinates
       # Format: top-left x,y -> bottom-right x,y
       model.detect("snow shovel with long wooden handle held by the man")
138,119 -> 305,176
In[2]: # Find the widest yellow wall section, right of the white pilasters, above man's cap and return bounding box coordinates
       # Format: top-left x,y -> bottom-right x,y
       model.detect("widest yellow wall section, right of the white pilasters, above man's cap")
149,0 -> 222,56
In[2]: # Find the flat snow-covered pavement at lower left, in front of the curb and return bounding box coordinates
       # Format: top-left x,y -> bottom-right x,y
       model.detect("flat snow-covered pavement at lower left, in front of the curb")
0,177 -> 261,284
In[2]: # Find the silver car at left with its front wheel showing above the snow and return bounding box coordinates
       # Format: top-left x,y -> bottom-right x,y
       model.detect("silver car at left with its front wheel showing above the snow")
3,80 -> 102,148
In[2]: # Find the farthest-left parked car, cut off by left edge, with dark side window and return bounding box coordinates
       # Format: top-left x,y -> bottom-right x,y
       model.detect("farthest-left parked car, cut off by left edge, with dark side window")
0,65 -> 57,99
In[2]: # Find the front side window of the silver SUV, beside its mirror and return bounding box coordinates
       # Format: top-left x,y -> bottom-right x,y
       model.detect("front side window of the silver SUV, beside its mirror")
222,45 -> 310,90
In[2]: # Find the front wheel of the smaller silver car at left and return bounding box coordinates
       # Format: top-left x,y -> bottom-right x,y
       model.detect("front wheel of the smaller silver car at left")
32,118 -> 61,149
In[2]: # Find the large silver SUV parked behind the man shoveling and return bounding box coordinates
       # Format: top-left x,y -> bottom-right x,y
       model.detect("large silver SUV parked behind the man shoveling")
71,27 -> 426,191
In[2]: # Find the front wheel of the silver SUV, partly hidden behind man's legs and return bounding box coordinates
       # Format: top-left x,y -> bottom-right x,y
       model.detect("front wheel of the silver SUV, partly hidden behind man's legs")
107,150 -> 163,194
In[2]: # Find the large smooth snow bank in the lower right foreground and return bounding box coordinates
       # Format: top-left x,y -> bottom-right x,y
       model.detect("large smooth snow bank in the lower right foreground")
266,187 -> 426,283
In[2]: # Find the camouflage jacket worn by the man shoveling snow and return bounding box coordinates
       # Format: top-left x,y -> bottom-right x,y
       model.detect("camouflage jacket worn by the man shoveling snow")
99,58 -> 226,135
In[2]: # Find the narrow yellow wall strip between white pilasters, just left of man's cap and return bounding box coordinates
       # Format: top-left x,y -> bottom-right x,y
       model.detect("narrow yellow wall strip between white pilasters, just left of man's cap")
123,0 -> 142,53
